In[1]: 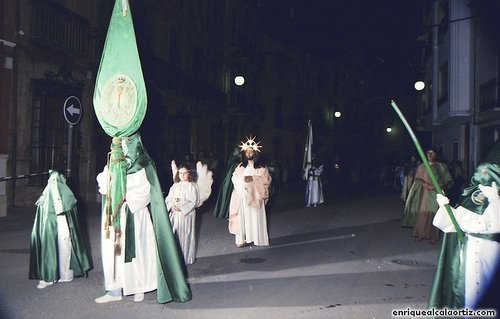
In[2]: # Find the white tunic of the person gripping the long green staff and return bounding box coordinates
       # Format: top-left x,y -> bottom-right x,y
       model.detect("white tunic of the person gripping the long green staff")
433,194 -> 500,308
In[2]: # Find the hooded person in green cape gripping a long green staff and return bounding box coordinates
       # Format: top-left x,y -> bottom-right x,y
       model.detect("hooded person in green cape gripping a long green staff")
428,162 -> 500,309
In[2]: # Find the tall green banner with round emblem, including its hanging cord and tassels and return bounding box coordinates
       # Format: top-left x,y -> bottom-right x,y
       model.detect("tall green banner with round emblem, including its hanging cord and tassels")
94,0 -> 147,255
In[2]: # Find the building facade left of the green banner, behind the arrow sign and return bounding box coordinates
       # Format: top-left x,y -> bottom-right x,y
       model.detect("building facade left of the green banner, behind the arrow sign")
0,0 -> 105,215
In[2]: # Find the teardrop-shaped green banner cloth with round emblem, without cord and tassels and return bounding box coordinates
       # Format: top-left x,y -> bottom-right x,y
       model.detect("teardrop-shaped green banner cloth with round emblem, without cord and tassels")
94,0 -> 147,137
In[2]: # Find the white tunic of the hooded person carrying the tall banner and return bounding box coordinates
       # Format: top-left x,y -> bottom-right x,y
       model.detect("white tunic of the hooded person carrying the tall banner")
97,169 -> 157,295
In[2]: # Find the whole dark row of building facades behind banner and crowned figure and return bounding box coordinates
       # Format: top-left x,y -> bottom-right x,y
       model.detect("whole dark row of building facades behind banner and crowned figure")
0,0 -> 342,216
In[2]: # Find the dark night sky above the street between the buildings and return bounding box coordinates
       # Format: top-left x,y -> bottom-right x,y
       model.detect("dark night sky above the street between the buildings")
258,0 -> 423,95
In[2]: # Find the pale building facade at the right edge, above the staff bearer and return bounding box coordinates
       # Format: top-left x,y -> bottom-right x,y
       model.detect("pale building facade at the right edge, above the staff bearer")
419,0 -> 500,176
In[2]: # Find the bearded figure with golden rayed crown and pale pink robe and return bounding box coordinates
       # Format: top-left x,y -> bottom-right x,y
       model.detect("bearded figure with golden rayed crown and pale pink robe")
229,136 -> 271,247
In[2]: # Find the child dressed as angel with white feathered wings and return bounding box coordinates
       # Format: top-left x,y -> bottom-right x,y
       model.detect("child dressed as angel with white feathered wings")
165,161 -> 213,264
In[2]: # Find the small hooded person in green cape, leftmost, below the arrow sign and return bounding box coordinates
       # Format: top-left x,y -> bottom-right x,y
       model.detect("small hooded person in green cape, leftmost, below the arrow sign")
29,170 -> 92,289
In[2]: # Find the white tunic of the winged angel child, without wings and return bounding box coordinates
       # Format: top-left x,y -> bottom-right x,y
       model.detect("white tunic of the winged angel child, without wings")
165,181 -> 199,264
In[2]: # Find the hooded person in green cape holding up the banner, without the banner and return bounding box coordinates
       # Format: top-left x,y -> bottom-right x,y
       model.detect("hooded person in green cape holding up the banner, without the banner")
95,132 -> 191,303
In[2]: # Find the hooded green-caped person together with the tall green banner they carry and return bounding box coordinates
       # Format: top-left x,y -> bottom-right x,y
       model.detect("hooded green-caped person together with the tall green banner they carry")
94,0 -> 191,303
